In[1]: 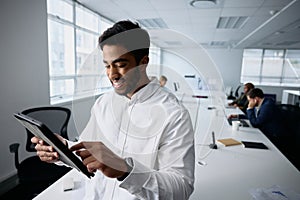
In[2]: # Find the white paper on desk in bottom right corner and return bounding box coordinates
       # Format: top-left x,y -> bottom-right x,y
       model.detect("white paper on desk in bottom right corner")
249,185 -> 300,200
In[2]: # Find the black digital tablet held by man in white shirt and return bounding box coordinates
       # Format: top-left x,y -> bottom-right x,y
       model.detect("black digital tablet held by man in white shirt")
14,113 -> 94,178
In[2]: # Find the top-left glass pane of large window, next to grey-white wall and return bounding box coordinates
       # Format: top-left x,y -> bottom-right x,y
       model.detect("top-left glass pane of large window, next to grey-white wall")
47,0 -> 73,22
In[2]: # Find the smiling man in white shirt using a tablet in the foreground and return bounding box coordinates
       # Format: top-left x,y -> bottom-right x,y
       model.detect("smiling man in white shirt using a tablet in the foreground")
31,21 -> 195,200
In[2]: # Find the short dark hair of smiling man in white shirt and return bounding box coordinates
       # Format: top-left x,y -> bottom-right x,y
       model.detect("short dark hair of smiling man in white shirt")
98,20 -> 150,63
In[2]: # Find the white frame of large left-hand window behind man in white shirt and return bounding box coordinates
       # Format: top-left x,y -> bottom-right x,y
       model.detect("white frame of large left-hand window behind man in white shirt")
47,0 -> 161,105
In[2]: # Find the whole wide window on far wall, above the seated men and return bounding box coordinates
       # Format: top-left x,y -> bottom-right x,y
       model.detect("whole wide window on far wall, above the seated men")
241,49 -> 300,87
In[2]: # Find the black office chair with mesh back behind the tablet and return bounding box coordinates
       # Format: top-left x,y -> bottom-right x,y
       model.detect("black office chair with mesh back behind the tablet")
9,106 -> 71,189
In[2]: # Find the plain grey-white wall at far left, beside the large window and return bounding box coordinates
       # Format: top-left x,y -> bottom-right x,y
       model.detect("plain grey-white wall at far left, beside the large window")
0,0 -> 49,181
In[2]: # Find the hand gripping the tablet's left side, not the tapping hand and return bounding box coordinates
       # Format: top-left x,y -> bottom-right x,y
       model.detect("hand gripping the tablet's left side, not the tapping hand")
31,134 -> 66,163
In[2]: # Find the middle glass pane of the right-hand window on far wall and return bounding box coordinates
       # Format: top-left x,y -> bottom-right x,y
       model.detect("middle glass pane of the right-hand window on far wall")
262,50 -> 284,80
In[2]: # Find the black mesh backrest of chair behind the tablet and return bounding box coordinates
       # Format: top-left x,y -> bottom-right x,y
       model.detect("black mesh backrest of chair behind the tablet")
21,106 -> 71,152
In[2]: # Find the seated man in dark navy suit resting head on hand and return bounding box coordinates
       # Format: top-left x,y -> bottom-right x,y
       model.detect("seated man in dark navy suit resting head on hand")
247,88 -> 289,149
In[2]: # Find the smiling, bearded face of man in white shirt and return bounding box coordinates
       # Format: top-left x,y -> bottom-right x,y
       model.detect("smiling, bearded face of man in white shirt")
103,45 -> 141,97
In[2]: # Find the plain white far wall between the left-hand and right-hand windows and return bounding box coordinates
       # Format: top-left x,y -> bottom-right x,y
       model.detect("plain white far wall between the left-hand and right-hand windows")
162,48 -> 243,94
